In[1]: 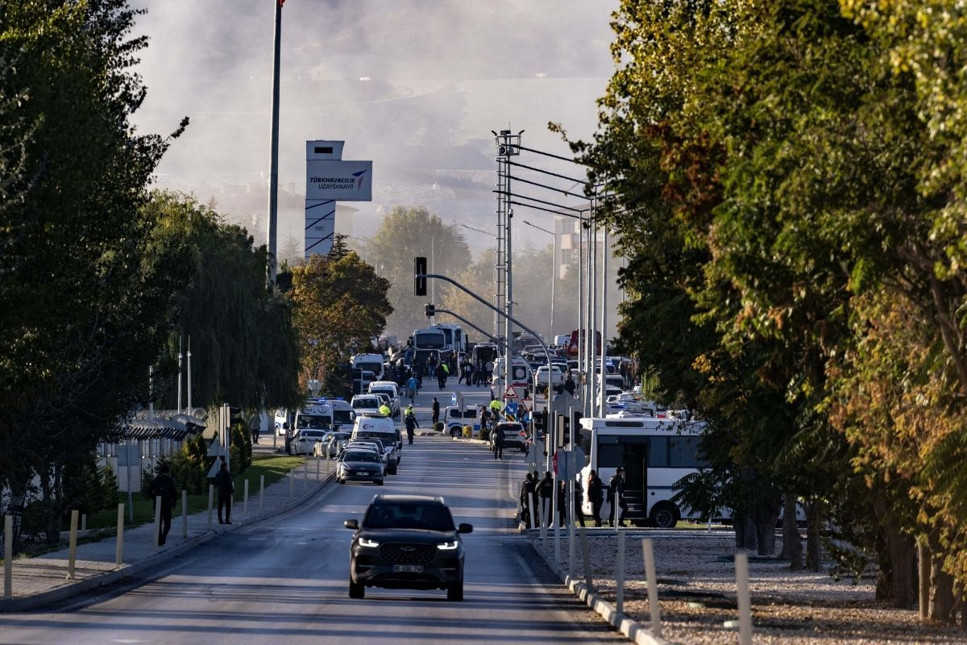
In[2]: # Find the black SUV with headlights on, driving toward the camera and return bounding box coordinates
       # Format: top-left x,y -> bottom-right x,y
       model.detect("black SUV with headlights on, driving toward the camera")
344,495 -> 473,600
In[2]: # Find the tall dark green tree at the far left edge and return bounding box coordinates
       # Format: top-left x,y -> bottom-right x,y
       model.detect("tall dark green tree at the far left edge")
0,0 -> 191,536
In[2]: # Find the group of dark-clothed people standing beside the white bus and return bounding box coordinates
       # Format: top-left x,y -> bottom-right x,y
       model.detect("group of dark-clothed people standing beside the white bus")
520,468 -> 628,527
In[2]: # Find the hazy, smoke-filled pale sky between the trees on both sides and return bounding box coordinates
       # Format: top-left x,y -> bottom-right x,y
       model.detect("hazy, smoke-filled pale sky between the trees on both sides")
131,0 -> 619,246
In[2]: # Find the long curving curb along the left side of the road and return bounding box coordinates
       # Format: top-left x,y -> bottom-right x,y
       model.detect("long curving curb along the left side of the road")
0,473 -> 333,614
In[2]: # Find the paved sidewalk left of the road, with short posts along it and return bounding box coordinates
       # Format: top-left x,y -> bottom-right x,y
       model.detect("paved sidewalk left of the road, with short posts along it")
0,446 -> 335,613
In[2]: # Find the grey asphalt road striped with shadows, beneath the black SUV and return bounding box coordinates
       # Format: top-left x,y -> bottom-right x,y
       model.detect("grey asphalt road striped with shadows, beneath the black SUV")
0,381 -> 627,645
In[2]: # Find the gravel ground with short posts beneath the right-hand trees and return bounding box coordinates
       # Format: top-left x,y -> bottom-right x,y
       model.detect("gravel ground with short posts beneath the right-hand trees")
538,530 -> 967,645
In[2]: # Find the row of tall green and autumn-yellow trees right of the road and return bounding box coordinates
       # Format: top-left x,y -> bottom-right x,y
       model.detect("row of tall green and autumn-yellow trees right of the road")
573,0 -> 967,620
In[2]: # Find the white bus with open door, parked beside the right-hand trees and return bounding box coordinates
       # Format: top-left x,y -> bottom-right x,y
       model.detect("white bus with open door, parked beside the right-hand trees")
580,417 -> 706,528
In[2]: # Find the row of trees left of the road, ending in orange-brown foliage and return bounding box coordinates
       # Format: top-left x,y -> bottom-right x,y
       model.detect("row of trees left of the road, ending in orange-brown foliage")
0,0 -> 391,539
